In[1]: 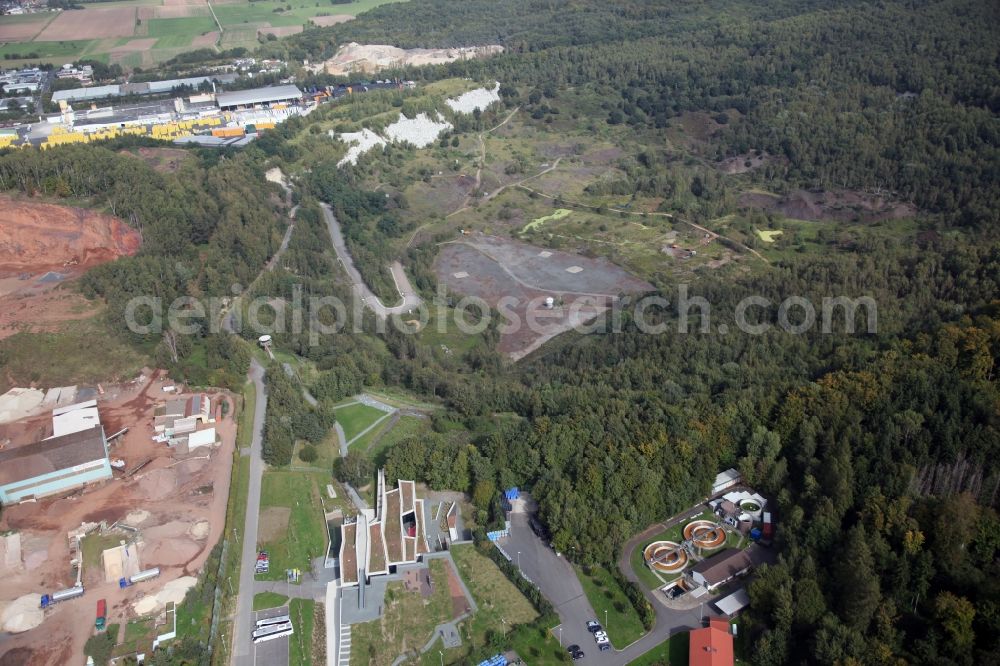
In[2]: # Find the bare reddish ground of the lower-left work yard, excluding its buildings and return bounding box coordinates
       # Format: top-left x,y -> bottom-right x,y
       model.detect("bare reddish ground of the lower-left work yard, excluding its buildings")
0,371 -> 236,666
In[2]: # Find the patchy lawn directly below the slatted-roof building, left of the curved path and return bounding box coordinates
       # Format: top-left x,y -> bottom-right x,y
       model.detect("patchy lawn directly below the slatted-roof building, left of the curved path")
351,559 -> 451,666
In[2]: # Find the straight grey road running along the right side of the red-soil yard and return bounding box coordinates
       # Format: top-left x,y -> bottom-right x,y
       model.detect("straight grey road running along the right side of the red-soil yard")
233,359 -> 268,666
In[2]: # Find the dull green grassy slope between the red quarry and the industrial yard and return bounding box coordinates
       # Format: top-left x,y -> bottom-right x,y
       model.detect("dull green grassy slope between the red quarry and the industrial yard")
0,316 -> 147,390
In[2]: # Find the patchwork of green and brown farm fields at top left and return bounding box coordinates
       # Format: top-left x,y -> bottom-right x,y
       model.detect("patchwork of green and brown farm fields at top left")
0,0 -> 405,67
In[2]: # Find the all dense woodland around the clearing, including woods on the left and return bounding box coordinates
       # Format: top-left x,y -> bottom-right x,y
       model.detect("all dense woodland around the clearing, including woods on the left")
0,0 -> 1000,666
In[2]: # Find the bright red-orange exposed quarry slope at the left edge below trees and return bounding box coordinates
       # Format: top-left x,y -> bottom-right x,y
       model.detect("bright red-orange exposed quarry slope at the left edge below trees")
0,195 -> 141,277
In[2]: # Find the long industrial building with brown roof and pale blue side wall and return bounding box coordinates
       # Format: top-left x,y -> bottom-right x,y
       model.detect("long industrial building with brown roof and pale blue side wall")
0,424 -> 111,504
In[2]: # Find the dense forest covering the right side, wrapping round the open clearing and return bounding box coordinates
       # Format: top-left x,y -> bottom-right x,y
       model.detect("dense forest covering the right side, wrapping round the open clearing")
267,0 -> 1000,664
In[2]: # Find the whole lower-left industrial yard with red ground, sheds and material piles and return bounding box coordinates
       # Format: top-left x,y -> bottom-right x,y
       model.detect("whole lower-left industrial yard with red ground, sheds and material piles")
0,371 -> 236,663
